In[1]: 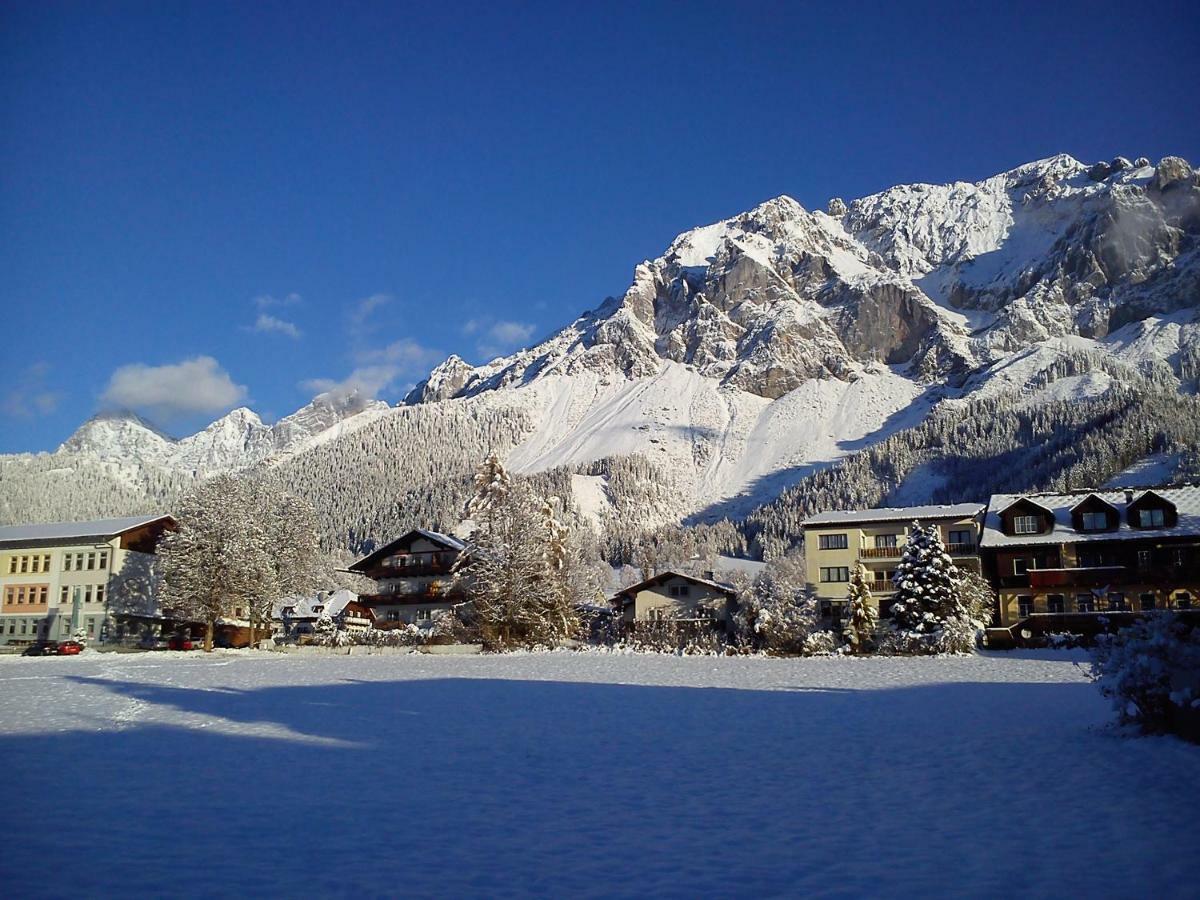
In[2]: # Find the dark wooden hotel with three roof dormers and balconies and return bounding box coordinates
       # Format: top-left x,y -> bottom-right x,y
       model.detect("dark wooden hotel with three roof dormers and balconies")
980,486 -> 1200,631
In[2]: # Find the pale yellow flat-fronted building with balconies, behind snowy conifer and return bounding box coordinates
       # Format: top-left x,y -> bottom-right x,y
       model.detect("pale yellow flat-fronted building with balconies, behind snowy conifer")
802,503 -> 984,617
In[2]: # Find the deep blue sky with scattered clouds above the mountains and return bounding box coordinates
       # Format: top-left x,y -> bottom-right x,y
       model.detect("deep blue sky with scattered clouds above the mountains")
0,1 -> 1200,452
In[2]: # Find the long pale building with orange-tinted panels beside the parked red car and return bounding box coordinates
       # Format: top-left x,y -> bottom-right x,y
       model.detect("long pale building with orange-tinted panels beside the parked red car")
0,516 -> 175,644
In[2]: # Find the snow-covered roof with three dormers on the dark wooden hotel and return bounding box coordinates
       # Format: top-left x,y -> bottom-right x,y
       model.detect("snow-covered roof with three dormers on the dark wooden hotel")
979,485 -> 1200,547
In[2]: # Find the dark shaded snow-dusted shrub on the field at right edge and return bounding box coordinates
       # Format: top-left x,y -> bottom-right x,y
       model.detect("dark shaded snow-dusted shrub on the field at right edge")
1092,611 -> 1200,733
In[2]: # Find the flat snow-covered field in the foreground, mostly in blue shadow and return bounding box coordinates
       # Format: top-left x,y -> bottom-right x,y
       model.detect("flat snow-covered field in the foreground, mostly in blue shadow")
0,652 -> 1200,898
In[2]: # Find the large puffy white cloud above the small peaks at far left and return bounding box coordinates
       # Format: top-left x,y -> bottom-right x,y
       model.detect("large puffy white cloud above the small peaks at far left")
101,356 -> 246,421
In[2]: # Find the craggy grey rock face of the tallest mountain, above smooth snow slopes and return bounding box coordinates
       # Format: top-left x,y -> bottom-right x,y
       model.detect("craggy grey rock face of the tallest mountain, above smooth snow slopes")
409,155 -> 1200,403
